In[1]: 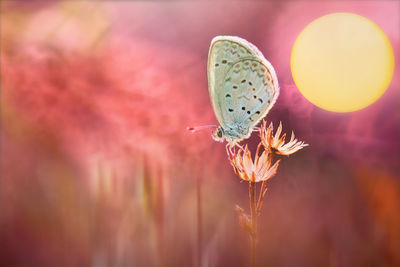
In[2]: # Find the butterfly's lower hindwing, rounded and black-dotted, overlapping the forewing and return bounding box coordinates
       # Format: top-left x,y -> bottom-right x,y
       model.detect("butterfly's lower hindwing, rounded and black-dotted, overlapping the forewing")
223,58 -> 279,139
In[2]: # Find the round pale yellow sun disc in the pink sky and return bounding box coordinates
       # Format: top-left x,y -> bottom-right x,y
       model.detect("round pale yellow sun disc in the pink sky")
290,13 -> 394,112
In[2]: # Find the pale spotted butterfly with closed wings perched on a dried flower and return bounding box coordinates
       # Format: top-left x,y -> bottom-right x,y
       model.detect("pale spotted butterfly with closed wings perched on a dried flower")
207,36 -> 279,144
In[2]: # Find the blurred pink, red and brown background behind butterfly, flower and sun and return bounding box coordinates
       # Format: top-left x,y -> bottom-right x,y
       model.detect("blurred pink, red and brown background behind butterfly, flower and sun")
0,0 -> 400,267
